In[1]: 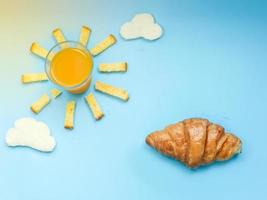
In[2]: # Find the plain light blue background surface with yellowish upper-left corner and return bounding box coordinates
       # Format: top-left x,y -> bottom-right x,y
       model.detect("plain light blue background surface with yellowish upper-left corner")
0,0 -> 267,200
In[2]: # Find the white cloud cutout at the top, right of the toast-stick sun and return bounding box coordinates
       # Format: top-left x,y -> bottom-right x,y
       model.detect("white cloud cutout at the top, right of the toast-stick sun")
120,13 -> 163,40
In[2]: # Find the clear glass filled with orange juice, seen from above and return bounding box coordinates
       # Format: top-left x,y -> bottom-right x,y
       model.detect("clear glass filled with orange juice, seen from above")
45,41 -> 93,94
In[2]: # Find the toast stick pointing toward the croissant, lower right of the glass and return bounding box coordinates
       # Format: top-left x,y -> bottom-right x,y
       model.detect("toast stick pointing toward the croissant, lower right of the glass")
95,81 -> 129,101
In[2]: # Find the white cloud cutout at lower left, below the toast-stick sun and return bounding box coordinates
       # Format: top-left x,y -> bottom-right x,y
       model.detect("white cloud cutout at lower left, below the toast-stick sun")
6,118 -> 56,152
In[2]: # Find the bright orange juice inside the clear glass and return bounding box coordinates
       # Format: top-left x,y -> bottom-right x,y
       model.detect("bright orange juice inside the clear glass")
50,47 -> 93,93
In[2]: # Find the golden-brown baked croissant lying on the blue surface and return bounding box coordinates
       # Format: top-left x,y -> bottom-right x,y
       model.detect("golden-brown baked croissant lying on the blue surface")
146,118 -> 242,168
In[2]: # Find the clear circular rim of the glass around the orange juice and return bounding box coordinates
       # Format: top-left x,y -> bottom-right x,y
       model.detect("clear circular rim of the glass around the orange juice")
44,40 -> 94,90
